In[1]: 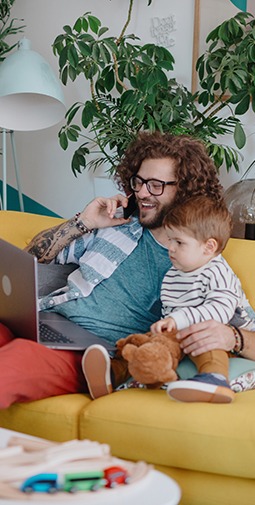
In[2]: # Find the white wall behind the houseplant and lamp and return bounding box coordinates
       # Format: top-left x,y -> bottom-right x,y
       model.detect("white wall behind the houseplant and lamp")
4,0 -> 255,217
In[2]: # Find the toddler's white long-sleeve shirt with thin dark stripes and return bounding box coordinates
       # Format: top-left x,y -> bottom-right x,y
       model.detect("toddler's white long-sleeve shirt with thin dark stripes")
161,255 -> 254,330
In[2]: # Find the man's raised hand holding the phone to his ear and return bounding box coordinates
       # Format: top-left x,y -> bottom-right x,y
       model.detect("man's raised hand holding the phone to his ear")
80,194 -> 129,230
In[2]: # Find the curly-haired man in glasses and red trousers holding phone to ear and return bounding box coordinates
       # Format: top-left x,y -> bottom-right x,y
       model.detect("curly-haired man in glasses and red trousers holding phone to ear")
0,132 -> 255,408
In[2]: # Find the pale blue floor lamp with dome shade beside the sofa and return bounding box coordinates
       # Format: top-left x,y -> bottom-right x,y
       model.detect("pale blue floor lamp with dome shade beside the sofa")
0,38 -> 66,210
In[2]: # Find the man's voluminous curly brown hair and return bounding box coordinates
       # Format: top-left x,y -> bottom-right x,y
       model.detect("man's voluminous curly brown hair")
115,131 -> 223,204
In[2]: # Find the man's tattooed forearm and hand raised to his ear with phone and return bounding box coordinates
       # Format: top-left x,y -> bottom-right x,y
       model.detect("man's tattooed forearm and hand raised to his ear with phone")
25,195 -> 128,263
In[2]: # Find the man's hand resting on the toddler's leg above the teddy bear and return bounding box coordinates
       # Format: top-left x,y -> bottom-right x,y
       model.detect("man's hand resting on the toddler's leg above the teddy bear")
176,319 -> 235,356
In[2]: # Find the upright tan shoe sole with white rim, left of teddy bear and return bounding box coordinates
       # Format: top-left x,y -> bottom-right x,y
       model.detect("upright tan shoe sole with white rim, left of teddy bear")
81,344 -> 112,400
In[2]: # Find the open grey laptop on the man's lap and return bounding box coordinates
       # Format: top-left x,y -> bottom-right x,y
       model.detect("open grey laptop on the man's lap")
0,239 -> 115,351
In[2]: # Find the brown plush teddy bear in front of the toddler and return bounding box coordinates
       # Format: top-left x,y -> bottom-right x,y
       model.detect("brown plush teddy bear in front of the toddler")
116,331 -> 182,389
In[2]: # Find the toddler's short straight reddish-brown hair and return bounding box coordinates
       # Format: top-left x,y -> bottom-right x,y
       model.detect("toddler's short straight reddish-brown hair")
163,196 -> 232,253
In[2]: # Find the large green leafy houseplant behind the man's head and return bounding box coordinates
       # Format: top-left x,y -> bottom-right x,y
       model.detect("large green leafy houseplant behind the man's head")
53,0 -> 255,175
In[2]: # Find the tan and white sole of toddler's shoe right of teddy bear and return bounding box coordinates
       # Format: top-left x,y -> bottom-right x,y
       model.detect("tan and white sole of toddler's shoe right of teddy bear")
167,380 -> 235,403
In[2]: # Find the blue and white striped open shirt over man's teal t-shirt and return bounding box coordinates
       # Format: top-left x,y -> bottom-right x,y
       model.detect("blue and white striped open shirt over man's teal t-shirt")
39,218 -> 143,310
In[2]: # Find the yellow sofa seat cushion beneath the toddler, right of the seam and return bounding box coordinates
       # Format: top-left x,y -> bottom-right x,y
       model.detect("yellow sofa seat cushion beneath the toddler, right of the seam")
80,389 -> 255,479
